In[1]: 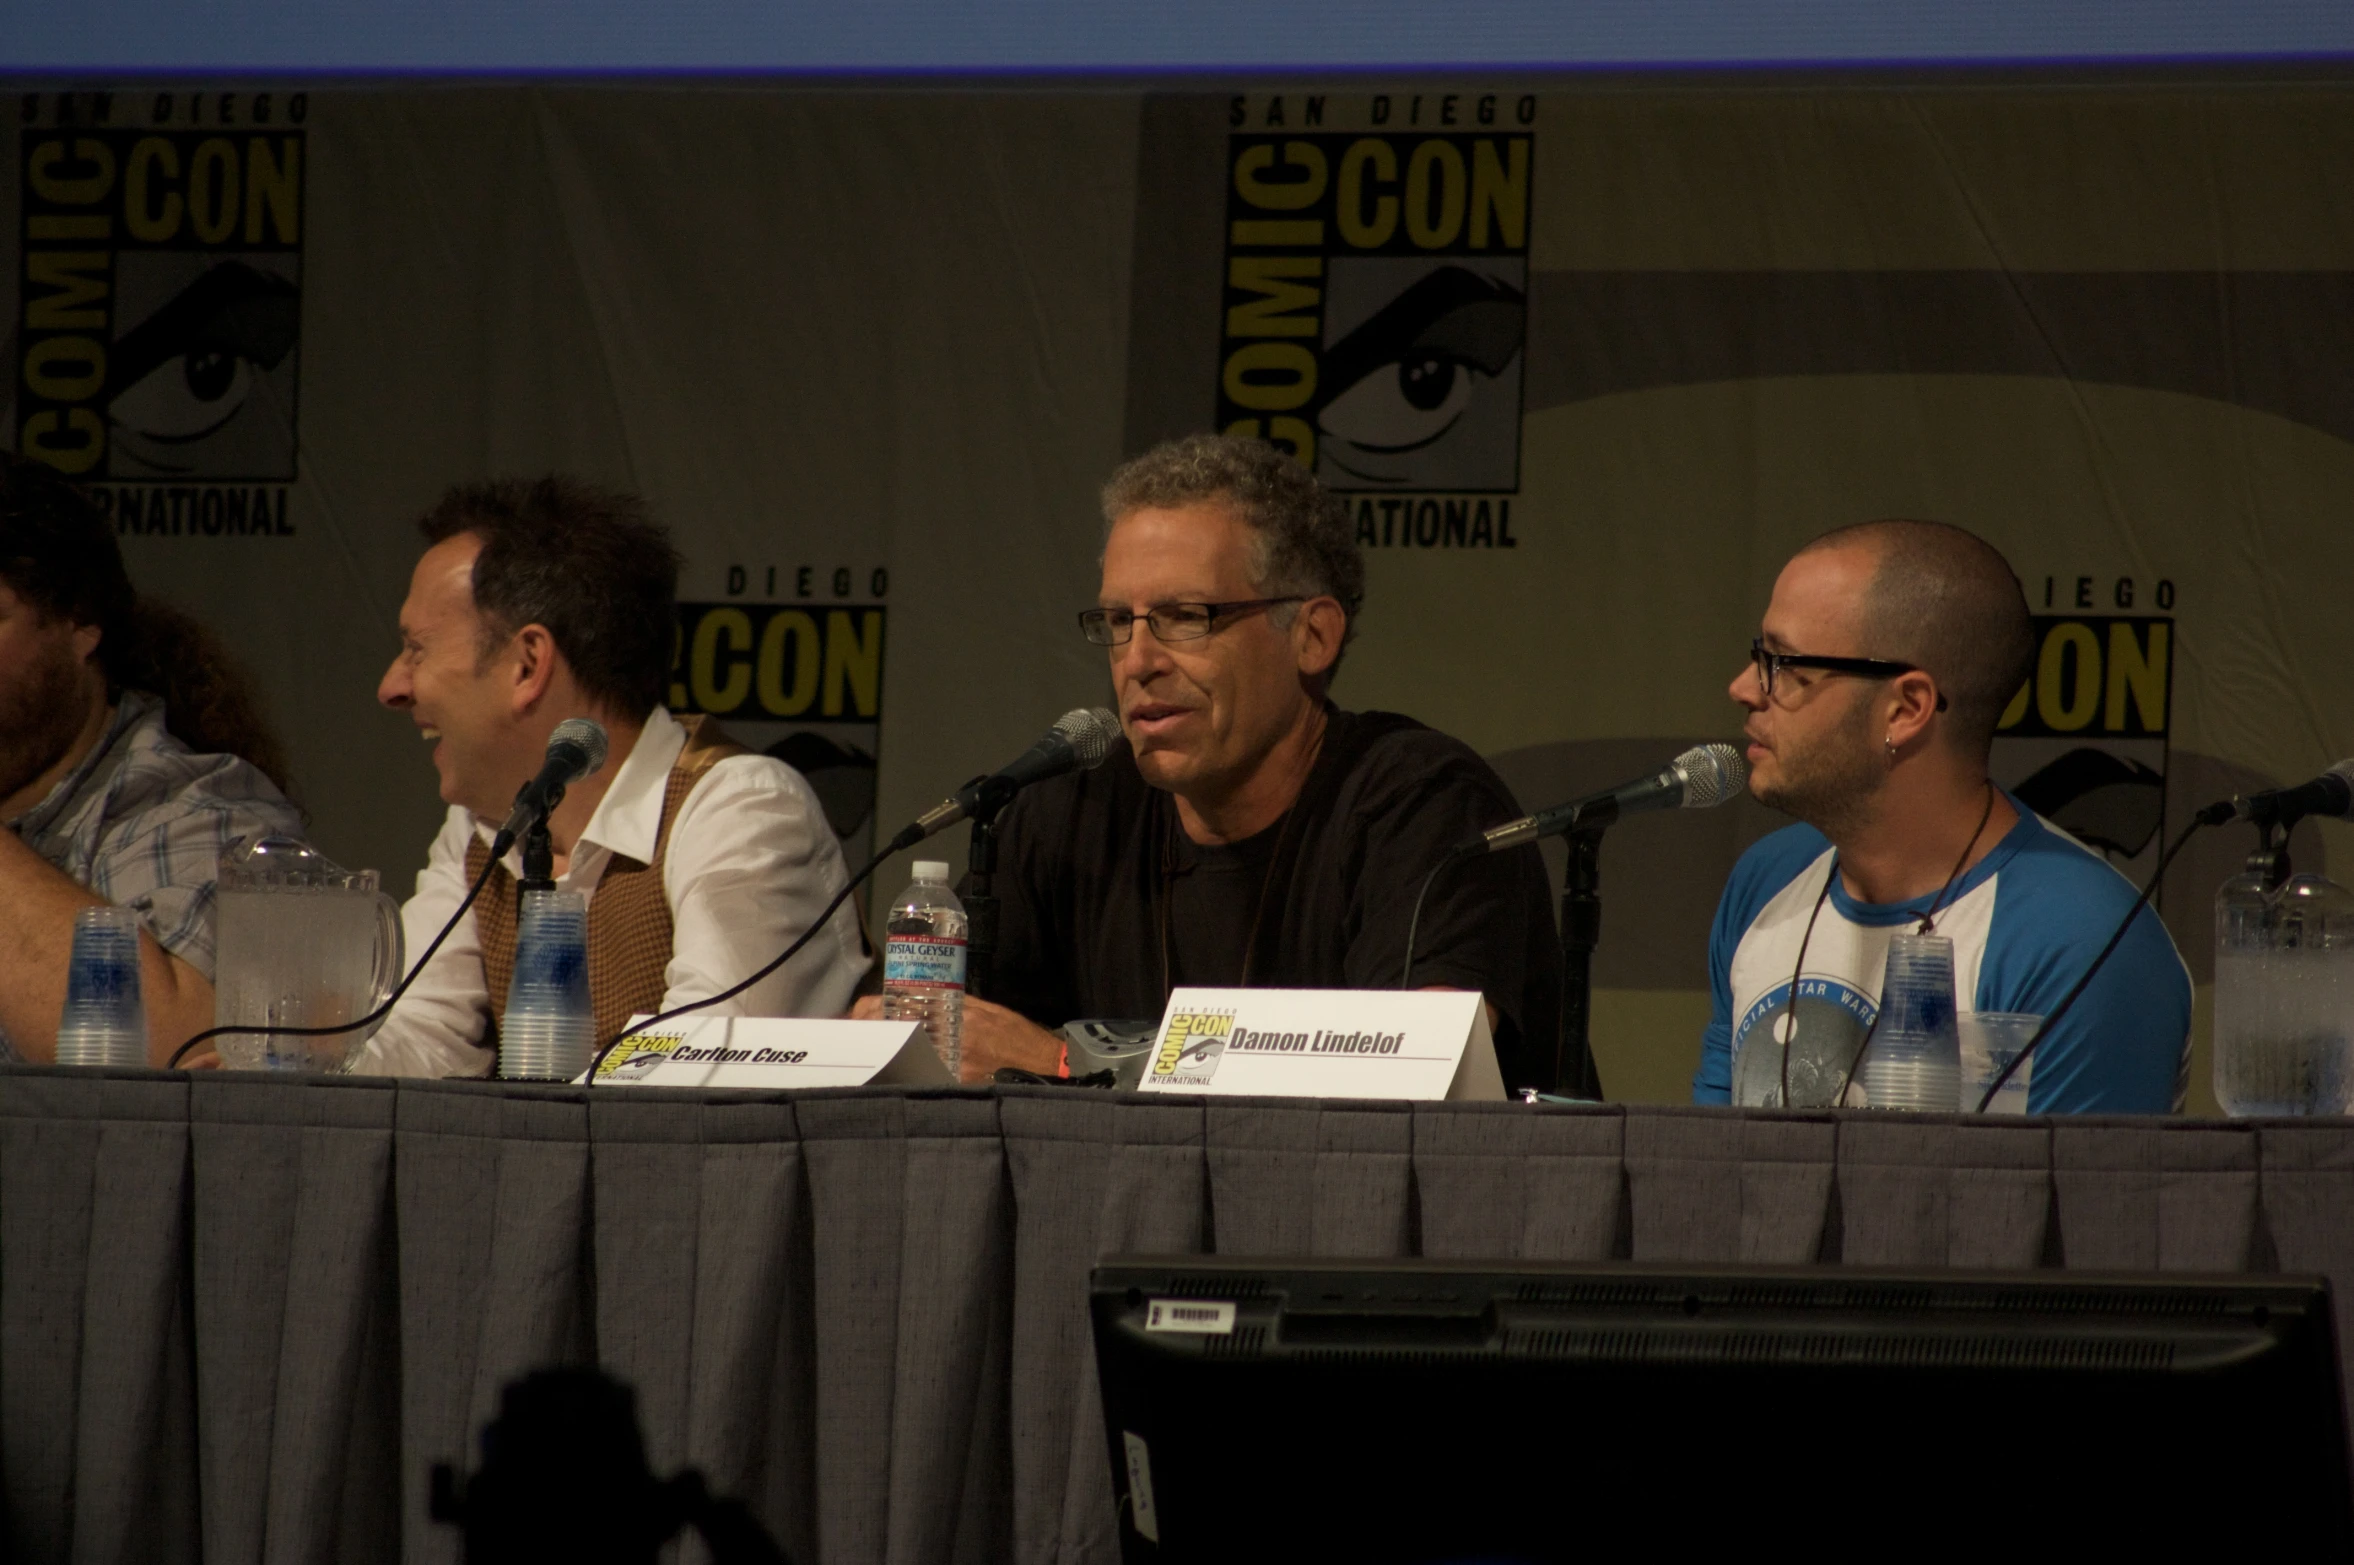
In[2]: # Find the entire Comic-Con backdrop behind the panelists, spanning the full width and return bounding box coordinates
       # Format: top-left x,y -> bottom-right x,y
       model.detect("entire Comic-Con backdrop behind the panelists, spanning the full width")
0,82 -> 2354,1097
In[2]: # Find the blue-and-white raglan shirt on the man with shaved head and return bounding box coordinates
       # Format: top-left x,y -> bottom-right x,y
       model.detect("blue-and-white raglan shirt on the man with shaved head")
1693,798 -> 2192,1113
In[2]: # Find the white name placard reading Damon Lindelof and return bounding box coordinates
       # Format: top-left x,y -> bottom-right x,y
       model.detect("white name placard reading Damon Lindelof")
1137,988 -> 1504,1101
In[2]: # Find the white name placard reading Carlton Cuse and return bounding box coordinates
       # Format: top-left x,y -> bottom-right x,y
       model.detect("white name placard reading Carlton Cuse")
596,1017 -> 949,1092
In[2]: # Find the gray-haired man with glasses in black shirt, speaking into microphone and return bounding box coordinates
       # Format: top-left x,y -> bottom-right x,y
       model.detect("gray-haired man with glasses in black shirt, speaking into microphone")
899,435 -> 1575,1087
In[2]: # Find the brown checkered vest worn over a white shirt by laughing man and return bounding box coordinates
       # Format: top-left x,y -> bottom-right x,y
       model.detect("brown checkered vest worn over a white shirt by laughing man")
466,715 -> 751,1047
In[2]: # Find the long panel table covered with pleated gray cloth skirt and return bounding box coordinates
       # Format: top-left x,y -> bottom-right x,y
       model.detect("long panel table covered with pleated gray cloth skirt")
0,1066 -> 2354,1565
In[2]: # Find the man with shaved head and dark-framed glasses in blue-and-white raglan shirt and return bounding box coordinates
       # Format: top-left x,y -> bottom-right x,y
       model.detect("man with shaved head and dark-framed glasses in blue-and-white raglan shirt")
1693,520 -> 2192,1113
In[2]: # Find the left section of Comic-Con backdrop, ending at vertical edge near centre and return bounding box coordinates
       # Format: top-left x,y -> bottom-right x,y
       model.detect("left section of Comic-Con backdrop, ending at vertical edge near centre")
0,89 -> 1137,894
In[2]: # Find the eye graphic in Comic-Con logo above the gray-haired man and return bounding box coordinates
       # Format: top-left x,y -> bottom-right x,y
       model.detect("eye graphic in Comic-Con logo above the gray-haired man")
1316,259 -> 1528,490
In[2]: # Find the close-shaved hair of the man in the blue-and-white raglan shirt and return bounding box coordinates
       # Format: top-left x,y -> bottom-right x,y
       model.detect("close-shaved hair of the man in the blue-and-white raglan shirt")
1798,520 -> 2034,755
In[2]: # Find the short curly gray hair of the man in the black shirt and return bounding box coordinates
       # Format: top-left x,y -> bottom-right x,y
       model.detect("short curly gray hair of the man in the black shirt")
1104,435 -> 1365,678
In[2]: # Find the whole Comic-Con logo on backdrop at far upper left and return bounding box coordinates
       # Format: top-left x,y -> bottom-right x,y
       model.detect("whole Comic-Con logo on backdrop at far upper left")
14,92 -> 308,534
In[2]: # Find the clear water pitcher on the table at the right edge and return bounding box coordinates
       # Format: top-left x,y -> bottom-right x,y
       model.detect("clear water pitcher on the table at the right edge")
2215,871 -> 2354,1116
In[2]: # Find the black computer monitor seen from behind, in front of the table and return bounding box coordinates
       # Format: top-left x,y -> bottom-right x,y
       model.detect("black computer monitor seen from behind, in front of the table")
1092,1257 -> 2354,1565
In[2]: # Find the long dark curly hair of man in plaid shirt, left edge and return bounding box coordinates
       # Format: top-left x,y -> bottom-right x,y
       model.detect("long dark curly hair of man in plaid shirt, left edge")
0,452 -> 292,795
